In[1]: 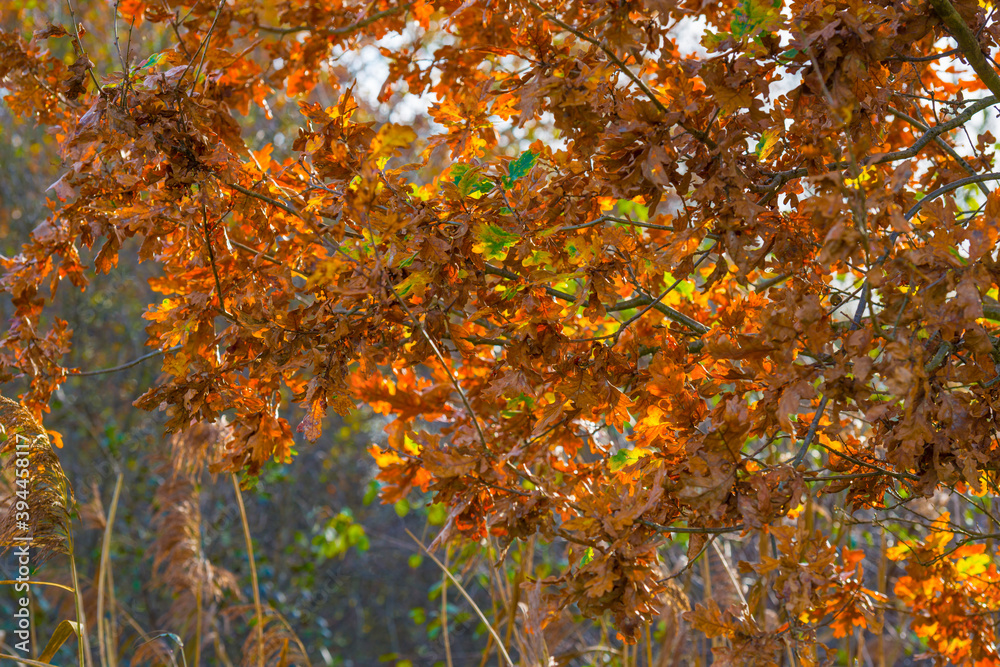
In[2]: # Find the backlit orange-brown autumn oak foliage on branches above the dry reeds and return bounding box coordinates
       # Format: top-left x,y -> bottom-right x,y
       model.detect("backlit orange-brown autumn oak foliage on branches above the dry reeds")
0,0 -> 1000,665
